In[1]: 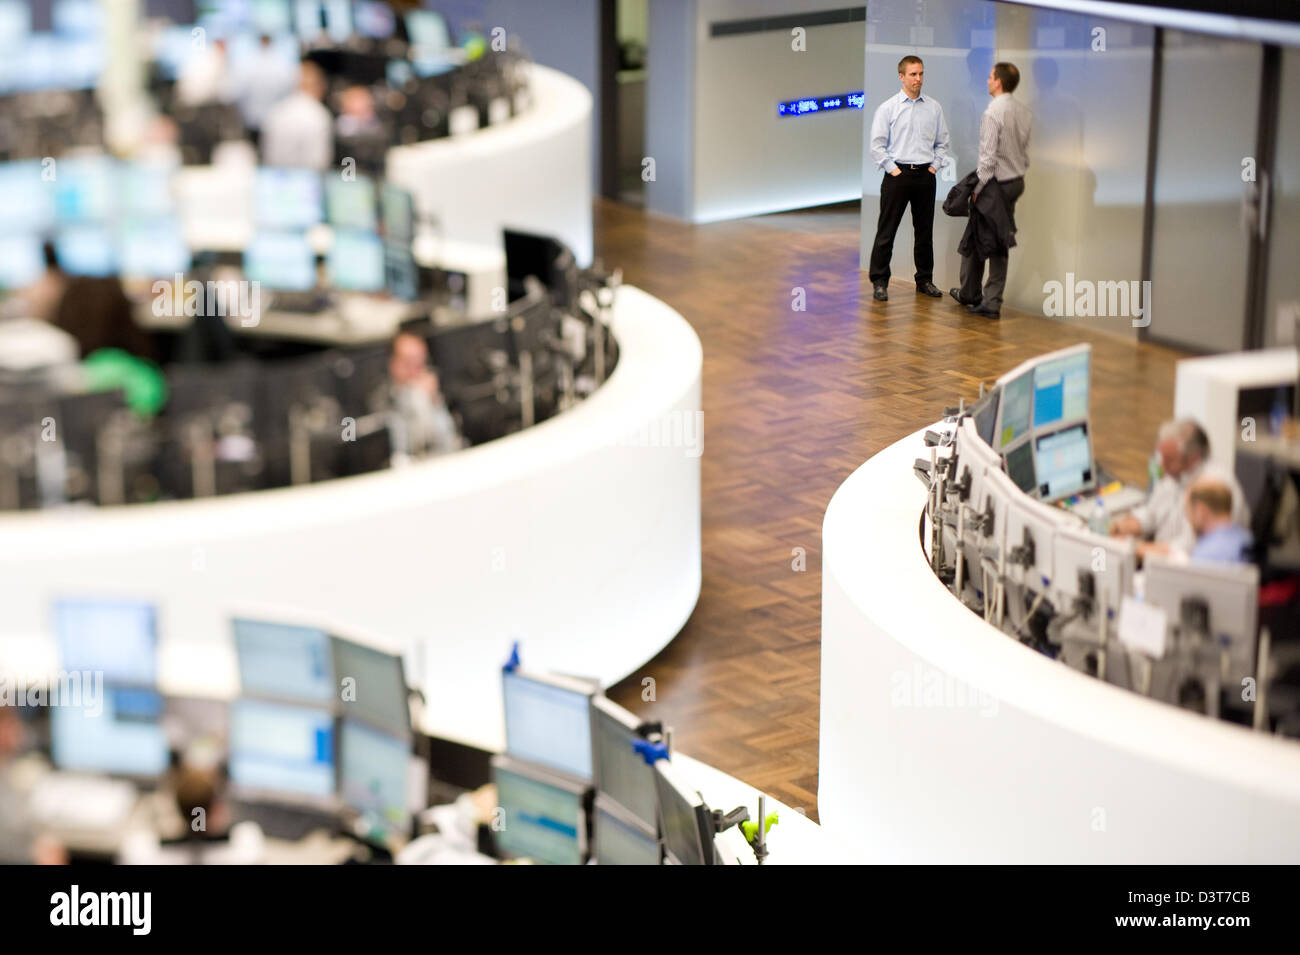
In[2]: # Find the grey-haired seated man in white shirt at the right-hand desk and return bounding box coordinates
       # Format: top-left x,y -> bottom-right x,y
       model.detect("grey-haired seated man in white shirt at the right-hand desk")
1110,418 -> 1251,556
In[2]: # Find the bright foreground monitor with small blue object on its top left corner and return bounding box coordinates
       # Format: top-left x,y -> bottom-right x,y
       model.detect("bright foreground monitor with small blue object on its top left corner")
502,670 -> 593,780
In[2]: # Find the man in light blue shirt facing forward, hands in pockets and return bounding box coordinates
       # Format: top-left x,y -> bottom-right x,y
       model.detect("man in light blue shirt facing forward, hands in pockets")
870,56 -> 948,301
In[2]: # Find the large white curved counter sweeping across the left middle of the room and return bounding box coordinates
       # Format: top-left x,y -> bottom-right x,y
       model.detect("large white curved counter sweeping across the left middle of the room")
0,286 -> 702,751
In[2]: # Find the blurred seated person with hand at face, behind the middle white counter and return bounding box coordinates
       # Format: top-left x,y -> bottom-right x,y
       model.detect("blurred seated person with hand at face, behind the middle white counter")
389,331 -> 464,461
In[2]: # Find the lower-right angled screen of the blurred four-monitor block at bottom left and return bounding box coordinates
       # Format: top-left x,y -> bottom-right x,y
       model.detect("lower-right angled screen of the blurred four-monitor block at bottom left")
338,717 -> 411,834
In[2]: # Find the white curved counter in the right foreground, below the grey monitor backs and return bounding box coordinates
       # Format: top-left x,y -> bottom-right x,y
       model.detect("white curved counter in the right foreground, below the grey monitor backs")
818,430 -> 1300,864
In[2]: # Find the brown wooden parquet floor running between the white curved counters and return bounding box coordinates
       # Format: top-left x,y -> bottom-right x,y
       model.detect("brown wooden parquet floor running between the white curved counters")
595,200 -> 1184,819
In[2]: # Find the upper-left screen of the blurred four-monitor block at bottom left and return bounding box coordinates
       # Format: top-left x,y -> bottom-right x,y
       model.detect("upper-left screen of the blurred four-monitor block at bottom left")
231,618 -> 338,704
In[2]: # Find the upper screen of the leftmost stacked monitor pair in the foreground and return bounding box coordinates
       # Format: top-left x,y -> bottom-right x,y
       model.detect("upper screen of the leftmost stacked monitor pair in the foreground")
53,598 -> 159,687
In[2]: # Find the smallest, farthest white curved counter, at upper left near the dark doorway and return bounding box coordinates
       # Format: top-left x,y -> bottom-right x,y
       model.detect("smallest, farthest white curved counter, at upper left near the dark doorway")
386,65 -> 592,268
